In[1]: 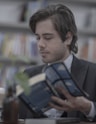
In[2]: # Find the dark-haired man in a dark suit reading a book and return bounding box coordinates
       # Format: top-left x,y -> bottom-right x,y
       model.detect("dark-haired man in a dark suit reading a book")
18,4 -> 96,121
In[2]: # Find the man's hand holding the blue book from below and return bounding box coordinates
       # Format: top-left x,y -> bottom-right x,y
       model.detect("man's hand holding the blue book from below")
49,87 -> 91,114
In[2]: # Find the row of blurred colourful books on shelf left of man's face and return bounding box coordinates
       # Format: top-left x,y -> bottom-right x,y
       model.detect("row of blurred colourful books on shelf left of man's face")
0,33 -> 39,58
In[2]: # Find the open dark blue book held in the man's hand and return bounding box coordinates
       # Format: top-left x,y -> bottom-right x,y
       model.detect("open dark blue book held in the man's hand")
17,62 -> 86,115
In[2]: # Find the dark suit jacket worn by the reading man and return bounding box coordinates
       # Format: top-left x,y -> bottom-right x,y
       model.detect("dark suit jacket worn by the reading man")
19,56 -> 96,120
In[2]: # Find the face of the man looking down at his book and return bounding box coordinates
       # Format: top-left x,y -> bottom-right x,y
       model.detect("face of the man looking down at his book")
35,19 -> 70,63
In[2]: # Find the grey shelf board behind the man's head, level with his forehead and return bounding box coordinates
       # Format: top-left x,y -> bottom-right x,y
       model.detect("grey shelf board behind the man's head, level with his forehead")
0,22 -> 96,37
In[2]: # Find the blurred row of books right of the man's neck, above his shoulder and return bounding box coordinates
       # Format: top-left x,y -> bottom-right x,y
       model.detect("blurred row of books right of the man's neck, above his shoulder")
77,37 -> 96,63
